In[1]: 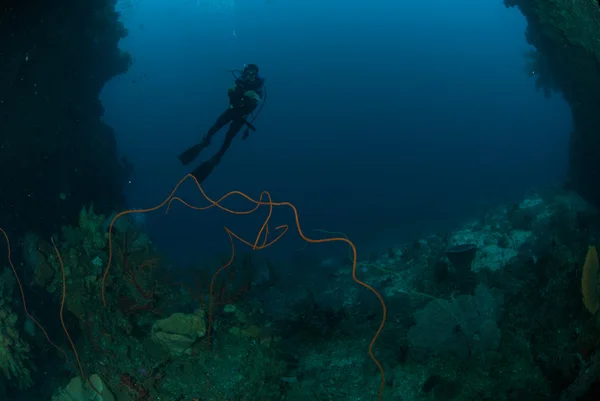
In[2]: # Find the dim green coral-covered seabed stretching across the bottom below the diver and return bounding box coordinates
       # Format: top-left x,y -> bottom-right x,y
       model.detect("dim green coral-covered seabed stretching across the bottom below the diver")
10,179 -> 600,401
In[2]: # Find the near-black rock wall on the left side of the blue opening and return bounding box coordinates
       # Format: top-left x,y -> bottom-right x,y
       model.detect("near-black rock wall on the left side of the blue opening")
0,0 -> 130,236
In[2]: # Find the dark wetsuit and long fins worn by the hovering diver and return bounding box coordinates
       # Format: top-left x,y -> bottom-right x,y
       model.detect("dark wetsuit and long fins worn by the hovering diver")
179,73 -> 263,182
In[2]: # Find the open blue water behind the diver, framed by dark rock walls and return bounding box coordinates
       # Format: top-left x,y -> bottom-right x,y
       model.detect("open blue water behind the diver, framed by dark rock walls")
102,0 -> 571,263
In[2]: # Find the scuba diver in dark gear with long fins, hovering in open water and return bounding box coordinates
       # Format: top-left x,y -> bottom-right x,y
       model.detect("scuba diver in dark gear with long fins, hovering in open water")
179,64 -> 266,183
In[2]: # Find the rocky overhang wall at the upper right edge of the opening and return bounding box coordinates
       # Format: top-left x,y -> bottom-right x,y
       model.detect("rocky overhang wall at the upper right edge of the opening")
504,0 -> 600,207
